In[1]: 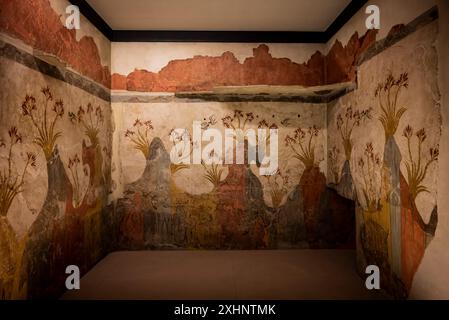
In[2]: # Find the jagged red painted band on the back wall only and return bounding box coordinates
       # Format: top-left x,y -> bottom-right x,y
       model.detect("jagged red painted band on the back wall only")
112,45 -> 324,92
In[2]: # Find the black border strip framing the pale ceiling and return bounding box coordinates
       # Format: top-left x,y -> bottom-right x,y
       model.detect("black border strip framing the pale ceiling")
69,0 -> 368,43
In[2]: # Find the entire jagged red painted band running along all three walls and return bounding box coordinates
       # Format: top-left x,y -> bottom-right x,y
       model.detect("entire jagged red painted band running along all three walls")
0,0 -> 401,92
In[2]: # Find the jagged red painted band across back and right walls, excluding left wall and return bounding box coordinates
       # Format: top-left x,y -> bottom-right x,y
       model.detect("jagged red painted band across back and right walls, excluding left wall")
108,30 -> 377,92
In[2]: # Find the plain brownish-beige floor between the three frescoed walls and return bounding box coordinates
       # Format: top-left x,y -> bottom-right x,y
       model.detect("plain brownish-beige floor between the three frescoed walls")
62,250 -> 382,300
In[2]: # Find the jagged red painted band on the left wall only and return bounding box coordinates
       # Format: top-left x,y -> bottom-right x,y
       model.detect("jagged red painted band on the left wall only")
0,0 -> 111,88
